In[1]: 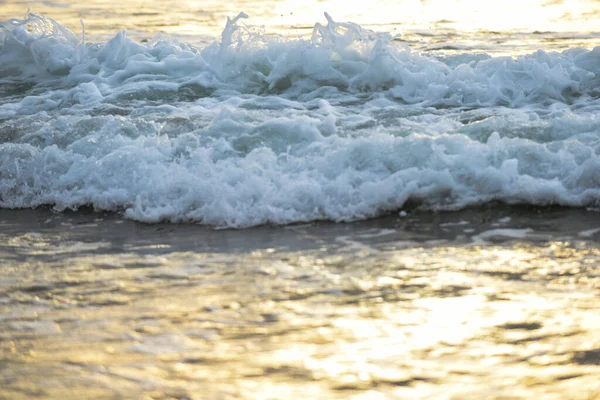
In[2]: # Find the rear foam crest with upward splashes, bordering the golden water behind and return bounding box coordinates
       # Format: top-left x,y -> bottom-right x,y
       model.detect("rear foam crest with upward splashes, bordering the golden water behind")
0,13 -> 600,107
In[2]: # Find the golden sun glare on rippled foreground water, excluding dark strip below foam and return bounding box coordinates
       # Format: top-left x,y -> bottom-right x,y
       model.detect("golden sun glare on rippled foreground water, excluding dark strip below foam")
0,227 -> 600,399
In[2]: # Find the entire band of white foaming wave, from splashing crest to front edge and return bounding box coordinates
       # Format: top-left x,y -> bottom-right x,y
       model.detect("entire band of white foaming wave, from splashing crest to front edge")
0,14 -> 600,227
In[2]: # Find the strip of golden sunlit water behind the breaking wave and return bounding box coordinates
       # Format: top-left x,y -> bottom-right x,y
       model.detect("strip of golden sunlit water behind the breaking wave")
0,0 -> 600,55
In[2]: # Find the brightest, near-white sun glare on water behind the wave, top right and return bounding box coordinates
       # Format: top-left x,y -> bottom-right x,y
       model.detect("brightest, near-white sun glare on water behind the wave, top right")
268,0 -> 600,32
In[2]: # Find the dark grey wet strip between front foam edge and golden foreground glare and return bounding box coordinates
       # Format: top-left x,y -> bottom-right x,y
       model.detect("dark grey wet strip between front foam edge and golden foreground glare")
0,203 -> 600,250
